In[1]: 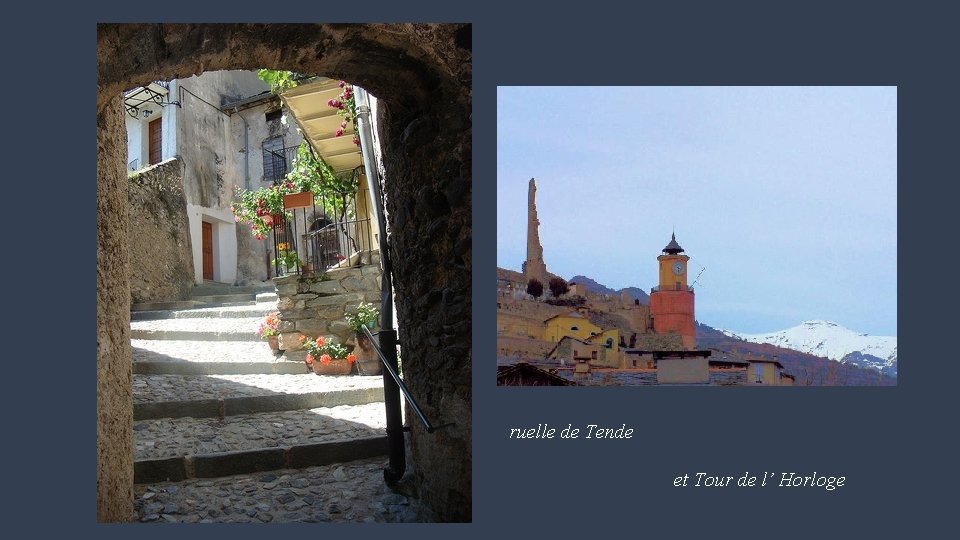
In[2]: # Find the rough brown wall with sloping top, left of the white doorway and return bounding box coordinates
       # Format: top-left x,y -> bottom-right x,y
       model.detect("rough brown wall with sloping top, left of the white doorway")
127,158 -> 193,303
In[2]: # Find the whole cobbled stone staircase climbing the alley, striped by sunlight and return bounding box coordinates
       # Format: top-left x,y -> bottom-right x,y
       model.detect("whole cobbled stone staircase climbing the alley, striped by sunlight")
131,286 -> 423,522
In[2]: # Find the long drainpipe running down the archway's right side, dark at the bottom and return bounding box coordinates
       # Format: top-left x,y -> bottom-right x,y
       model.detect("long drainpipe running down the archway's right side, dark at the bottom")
353,86 -> 406,485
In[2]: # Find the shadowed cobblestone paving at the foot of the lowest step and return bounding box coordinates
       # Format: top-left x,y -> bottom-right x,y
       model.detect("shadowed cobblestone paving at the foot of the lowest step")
133,457 -> 433,523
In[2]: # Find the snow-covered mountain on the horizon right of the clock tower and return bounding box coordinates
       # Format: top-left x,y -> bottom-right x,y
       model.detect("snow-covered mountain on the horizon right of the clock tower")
721,321 -> 897,377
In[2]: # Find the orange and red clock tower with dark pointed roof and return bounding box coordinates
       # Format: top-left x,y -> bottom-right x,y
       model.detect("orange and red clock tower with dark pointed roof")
650,235 -> 697,350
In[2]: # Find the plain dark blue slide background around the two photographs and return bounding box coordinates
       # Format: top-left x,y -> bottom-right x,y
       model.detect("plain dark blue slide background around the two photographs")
11,1 -> 960,538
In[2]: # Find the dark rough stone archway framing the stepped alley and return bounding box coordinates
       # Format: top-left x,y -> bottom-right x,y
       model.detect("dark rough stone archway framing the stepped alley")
97,24 -> 472,521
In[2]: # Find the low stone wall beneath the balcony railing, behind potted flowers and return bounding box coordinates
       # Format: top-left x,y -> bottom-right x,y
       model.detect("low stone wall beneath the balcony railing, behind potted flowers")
273,252 -> 381,350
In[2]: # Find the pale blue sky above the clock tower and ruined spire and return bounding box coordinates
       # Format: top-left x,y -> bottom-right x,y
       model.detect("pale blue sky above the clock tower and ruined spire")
497,87 -> 897,335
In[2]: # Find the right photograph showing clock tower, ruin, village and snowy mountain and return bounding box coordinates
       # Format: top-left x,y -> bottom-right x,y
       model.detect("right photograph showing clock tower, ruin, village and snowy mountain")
497,86 -> 896,387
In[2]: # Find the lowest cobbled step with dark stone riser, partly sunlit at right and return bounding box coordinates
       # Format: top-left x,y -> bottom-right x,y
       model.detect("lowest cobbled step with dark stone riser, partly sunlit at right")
133,402 -> 387,483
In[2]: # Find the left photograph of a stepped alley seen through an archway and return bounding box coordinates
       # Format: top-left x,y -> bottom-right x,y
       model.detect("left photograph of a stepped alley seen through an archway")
96,24 -> 472,523
